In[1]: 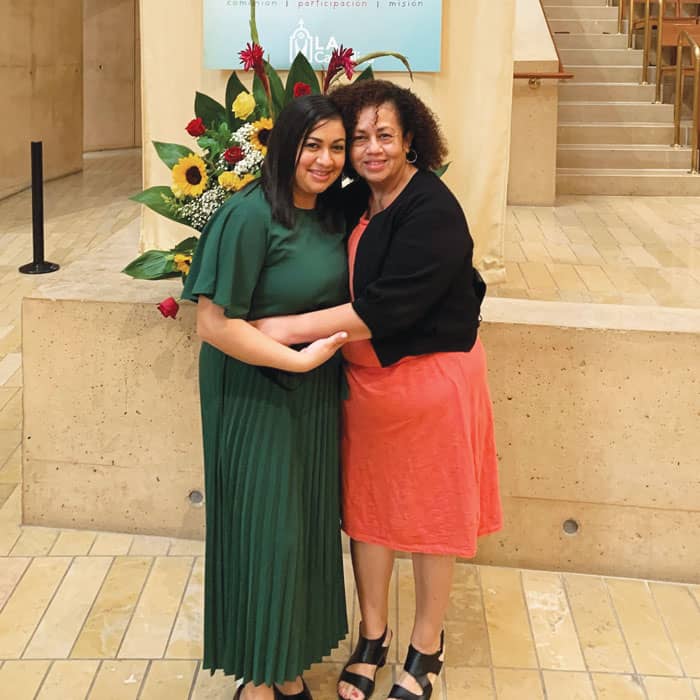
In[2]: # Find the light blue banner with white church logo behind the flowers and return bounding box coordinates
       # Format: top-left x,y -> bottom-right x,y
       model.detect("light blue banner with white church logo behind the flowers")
204,0 -> 442,72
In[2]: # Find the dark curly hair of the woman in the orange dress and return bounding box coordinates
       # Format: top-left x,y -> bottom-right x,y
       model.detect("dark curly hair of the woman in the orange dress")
330,80 -> 447,177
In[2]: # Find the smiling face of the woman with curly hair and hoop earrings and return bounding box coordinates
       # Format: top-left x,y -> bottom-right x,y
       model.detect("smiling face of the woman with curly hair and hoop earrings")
350,102 -> 413,187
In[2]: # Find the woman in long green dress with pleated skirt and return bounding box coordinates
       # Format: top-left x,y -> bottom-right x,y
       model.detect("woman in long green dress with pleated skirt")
183,95 -> 348,700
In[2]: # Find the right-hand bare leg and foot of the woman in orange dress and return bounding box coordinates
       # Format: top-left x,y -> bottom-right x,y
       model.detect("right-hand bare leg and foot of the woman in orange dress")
388,553 -> 455,695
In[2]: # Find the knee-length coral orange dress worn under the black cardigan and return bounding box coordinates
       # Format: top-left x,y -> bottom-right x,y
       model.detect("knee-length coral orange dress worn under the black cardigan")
342,218 -> 502,557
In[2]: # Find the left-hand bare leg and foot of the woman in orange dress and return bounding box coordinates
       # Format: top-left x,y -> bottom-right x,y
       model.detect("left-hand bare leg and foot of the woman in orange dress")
338,540 -> 394,700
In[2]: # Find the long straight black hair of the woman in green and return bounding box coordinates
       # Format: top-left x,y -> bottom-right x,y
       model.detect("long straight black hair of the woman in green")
262,95 -> 341,228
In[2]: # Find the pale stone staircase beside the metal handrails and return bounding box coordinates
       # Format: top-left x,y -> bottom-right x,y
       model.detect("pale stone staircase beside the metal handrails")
543,0 -> 700,196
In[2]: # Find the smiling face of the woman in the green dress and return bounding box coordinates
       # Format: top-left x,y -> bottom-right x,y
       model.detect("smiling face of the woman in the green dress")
294,117 -> 345,209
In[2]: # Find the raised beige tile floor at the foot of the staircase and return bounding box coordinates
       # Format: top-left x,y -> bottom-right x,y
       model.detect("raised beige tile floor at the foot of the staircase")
498,195 -> 700,308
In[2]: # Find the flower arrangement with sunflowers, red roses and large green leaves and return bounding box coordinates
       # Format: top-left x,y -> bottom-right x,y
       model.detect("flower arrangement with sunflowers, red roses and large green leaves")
123,0 -> 411,296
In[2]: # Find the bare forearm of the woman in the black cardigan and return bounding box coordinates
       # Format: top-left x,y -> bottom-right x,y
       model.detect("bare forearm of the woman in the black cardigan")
251,304 -> 372,345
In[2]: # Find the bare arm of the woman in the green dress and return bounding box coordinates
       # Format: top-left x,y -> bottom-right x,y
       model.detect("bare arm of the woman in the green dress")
197,296 -> 348,372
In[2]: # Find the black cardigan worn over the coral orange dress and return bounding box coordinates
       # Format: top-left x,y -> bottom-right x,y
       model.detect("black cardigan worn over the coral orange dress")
343,171 -> 483,367
